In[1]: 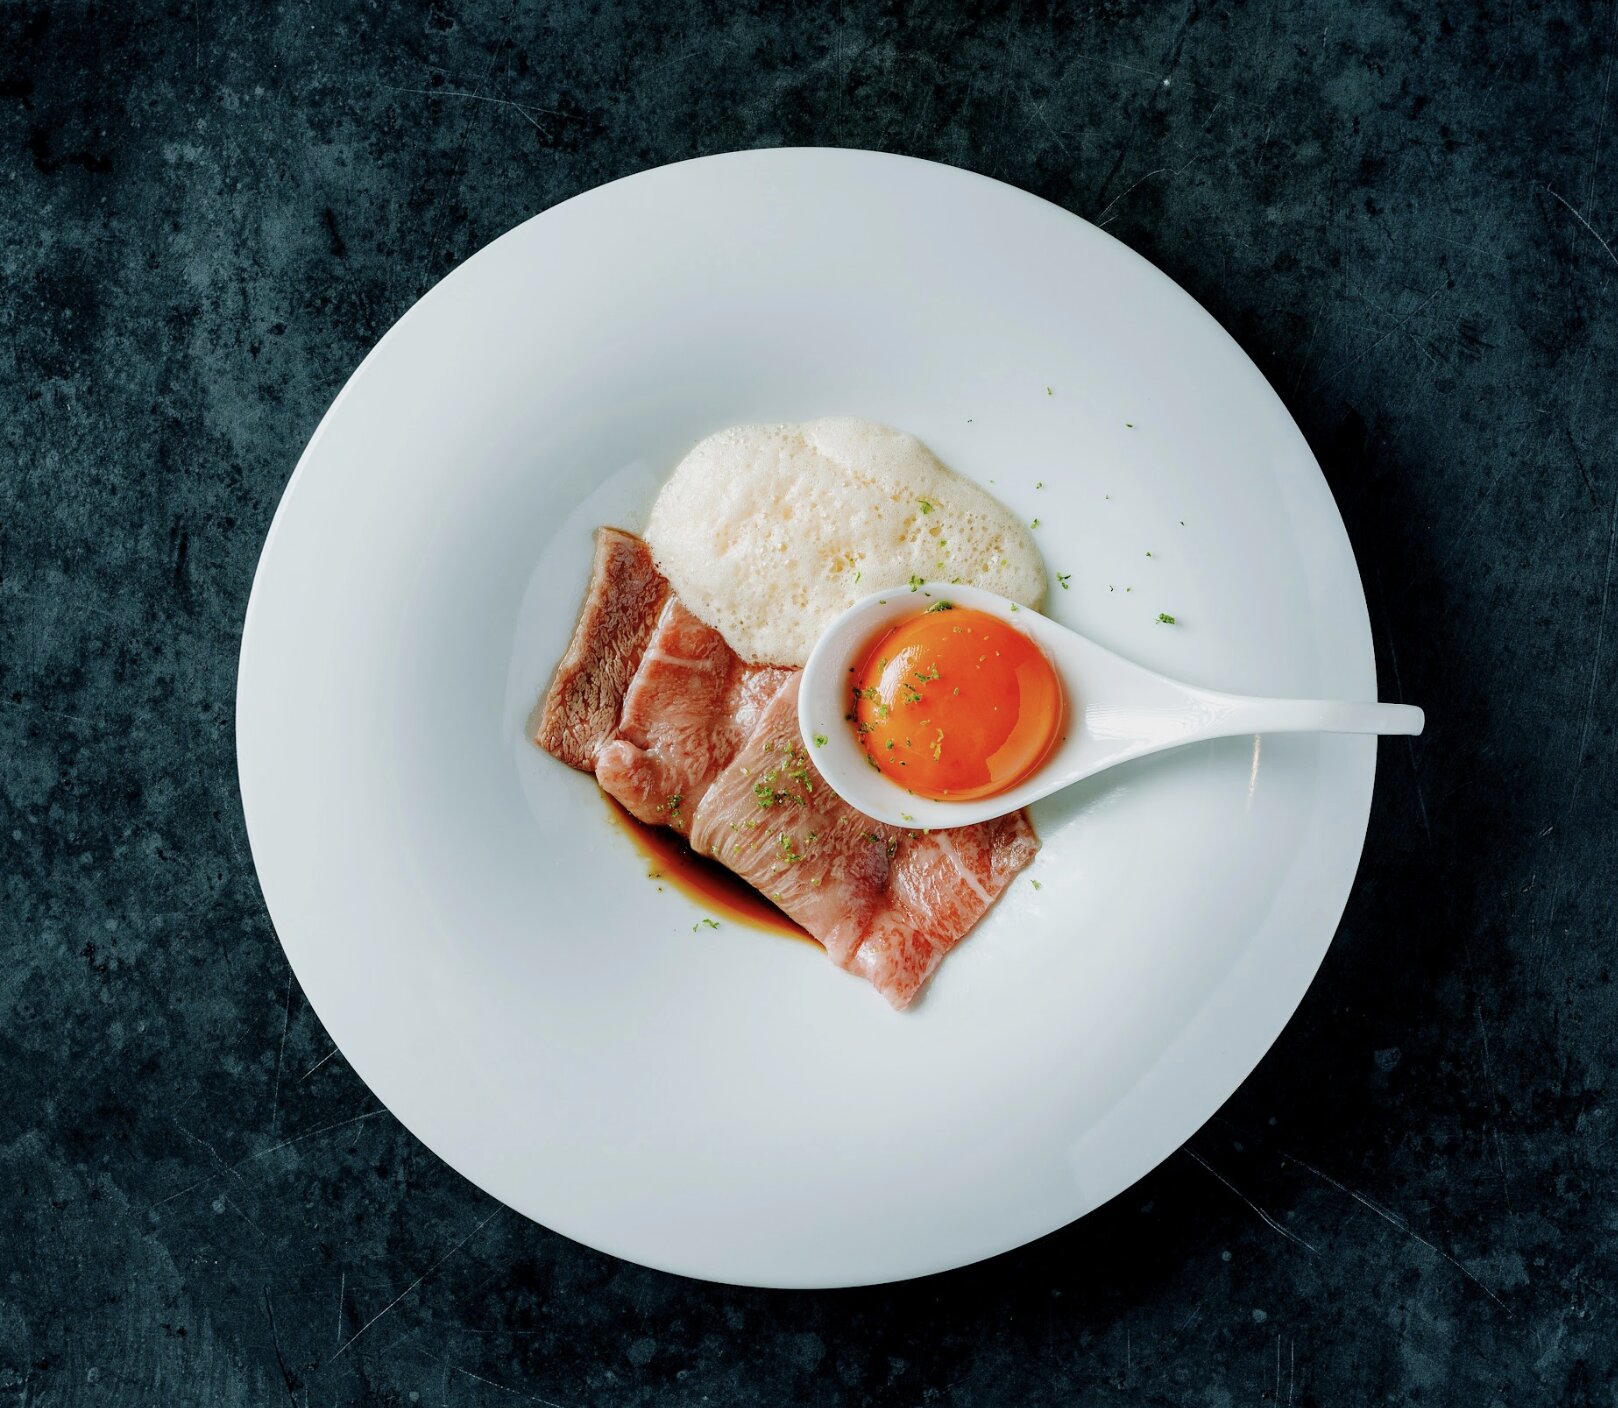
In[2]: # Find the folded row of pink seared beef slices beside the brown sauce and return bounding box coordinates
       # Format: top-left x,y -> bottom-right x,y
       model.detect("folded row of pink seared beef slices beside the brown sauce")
534,528 -> 1039,1007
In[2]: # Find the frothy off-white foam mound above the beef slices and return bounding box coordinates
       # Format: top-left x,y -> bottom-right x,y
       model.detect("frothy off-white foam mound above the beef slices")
646,419 -> 1045,665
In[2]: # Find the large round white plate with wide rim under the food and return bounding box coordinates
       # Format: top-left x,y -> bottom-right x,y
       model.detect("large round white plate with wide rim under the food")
236,149 -> 1375,1287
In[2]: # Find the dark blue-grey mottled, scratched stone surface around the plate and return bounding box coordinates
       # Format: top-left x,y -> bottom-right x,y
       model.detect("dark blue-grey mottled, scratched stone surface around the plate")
0,0 -> 1618,1408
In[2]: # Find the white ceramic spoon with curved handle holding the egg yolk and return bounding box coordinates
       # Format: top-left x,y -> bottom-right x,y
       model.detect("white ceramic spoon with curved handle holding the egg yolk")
798,583 -> 1424,829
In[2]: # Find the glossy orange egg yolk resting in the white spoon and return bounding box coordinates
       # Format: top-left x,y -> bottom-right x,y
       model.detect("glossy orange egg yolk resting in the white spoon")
851,602 -> 1066,801
